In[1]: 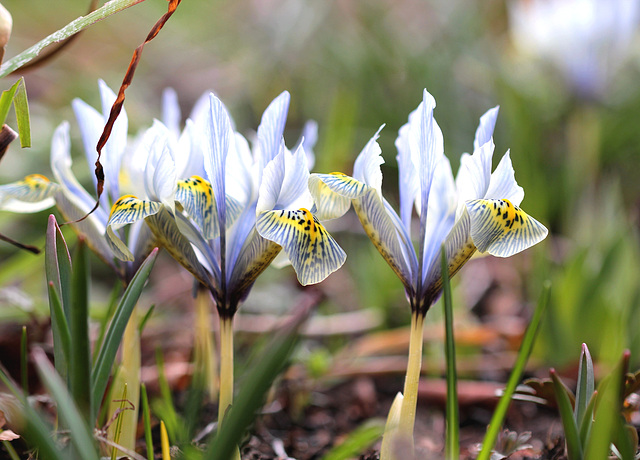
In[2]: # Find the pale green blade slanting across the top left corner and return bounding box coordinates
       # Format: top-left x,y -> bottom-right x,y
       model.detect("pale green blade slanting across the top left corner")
0,0 -> 144,78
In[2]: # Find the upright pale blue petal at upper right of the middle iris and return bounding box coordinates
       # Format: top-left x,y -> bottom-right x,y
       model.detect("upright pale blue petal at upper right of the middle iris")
258,91 -> 291,178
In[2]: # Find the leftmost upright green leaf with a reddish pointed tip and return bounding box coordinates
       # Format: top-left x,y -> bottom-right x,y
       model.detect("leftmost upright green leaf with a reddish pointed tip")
45,214 -> 71,379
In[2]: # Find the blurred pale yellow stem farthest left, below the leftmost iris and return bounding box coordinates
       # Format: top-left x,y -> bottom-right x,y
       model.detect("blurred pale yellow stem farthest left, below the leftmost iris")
109,307 -> 140,450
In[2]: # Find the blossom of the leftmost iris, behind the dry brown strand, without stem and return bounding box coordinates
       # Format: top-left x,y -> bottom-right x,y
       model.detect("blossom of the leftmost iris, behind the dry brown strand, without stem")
0,81 -> 161,282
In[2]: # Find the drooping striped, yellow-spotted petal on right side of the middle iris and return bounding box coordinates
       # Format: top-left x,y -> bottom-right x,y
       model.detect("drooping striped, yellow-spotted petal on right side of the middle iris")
256,208 -> 347,286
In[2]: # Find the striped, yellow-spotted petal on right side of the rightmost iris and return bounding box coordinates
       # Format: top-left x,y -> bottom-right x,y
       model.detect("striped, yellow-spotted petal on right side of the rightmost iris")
465,199 -> 549,257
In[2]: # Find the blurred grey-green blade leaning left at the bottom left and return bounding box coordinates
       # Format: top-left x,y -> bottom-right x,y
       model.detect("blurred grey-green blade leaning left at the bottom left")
32,349 -> 99,460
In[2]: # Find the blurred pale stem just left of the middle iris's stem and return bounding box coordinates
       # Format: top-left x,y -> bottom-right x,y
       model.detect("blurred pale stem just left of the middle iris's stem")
194,289 -> 218,401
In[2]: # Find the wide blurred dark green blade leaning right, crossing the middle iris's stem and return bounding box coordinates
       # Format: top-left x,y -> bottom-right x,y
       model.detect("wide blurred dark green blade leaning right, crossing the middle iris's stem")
203,310 -> 308,460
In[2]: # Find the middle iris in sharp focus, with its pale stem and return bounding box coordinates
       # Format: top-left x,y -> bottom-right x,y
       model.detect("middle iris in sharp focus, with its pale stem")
107,92 -> 346,438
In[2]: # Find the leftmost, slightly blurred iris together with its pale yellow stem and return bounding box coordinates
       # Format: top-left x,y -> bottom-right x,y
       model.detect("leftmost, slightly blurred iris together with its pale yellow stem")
0,81 -> 189,449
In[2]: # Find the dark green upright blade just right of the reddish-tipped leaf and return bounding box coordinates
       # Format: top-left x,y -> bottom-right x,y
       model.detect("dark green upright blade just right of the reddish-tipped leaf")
69,238 -> 92,421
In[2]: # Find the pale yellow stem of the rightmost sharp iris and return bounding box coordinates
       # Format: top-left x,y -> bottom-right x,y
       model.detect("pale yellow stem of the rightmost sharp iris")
398,313 -> 424,447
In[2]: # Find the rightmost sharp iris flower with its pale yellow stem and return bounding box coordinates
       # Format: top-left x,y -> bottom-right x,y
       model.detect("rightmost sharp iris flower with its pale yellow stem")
310,90 -> 547,452
